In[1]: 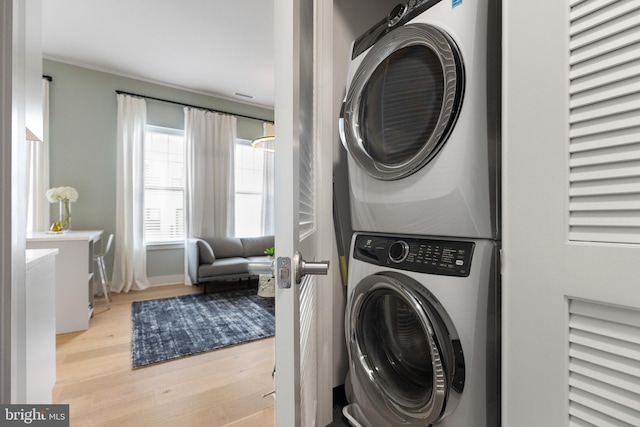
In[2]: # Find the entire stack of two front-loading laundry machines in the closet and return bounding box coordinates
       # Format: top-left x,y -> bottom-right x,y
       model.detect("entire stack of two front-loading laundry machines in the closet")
340,0 -> 500,427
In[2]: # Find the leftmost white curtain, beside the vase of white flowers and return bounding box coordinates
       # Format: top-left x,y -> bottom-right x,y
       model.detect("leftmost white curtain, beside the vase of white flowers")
27,79 -> 49,233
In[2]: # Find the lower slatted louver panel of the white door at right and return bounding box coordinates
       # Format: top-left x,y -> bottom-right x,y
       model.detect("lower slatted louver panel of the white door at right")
569,300 -> 640,426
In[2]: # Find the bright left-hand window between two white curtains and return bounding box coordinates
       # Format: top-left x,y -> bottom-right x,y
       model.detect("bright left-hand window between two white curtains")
144,126 -> 185,244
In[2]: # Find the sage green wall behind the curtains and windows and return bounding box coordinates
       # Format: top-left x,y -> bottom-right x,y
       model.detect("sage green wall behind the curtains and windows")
43,59 -> 274,281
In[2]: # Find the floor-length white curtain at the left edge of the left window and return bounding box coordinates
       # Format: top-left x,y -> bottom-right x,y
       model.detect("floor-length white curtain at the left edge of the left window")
111,94 -> 149,292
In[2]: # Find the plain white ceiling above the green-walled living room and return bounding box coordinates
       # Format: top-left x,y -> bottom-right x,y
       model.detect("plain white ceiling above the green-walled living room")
42,0 -> 274,107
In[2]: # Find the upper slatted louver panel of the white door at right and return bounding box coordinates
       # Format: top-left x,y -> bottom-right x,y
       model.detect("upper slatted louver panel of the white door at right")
569,1 -> 640,243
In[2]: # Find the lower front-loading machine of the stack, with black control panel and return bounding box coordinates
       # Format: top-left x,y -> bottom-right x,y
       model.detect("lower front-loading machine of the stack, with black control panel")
343,233 -> 500,427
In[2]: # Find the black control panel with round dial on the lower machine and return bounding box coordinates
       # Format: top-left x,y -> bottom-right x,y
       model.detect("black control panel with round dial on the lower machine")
353,234 -> 475,277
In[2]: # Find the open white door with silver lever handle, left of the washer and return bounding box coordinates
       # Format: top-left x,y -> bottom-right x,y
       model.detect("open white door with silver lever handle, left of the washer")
275,0 -> 333,427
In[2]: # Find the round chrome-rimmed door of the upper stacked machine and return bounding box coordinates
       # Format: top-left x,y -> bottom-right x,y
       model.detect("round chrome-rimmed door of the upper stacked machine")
341,24 -> 464,180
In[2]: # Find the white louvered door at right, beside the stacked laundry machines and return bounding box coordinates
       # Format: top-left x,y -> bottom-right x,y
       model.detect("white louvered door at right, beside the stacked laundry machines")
502,0 -> 640,427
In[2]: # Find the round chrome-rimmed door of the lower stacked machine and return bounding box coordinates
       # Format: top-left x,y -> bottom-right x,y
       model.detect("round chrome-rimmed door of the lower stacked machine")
346,272 -> 465,426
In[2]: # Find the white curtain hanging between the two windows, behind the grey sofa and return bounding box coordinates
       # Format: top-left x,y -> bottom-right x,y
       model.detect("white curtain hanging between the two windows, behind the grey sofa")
184,107 -> 237,284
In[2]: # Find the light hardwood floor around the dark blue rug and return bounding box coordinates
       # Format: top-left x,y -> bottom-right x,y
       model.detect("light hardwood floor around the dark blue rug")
53,285 -> 274,427
